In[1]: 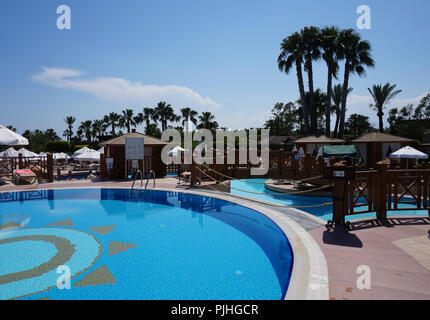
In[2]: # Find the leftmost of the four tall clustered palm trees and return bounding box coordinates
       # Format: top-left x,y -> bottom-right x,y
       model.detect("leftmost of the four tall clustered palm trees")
278,32 -> 310,135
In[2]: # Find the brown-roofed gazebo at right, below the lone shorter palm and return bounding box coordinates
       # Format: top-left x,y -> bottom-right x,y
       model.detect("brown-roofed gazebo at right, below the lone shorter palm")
352,132 -> 415,168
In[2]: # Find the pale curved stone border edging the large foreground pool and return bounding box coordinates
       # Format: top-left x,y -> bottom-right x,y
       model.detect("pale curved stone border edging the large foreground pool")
0,186 -> 329,300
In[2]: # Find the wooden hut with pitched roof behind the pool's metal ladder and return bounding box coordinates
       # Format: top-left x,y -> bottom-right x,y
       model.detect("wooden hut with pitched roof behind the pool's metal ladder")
100,130 -> 167,179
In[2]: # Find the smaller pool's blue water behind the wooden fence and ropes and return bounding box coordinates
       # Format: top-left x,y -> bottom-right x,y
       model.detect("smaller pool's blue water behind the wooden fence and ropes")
230,179 -> 427,221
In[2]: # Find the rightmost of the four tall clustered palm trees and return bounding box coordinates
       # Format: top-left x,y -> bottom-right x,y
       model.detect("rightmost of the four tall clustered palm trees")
337,29 -> 375,138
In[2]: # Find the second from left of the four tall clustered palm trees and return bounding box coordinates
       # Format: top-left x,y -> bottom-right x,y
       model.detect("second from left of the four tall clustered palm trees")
301,27 -> 321,133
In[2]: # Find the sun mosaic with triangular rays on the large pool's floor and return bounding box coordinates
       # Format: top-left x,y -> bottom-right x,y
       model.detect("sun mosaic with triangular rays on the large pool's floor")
0,219 -> 137,300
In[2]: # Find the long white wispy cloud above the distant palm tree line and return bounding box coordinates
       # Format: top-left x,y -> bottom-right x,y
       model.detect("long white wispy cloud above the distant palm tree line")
32,68 -> 220,110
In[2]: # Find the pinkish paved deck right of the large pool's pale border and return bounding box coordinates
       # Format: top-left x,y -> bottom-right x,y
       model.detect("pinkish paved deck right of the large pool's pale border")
310,216 -> 430,300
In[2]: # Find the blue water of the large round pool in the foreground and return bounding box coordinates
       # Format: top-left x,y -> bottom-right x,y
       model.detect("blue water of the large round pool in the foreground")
0,189 -> 293,299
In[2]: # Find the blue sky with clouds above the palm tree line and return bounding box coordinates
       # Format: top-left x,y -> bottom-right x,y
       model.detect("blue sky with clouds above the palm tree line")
0,0 -> 430,135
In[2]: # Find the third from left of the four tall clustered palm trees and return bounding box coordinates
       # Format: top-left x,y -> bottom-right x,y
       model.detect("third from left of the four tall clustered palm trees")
321,27 -> 339,137
